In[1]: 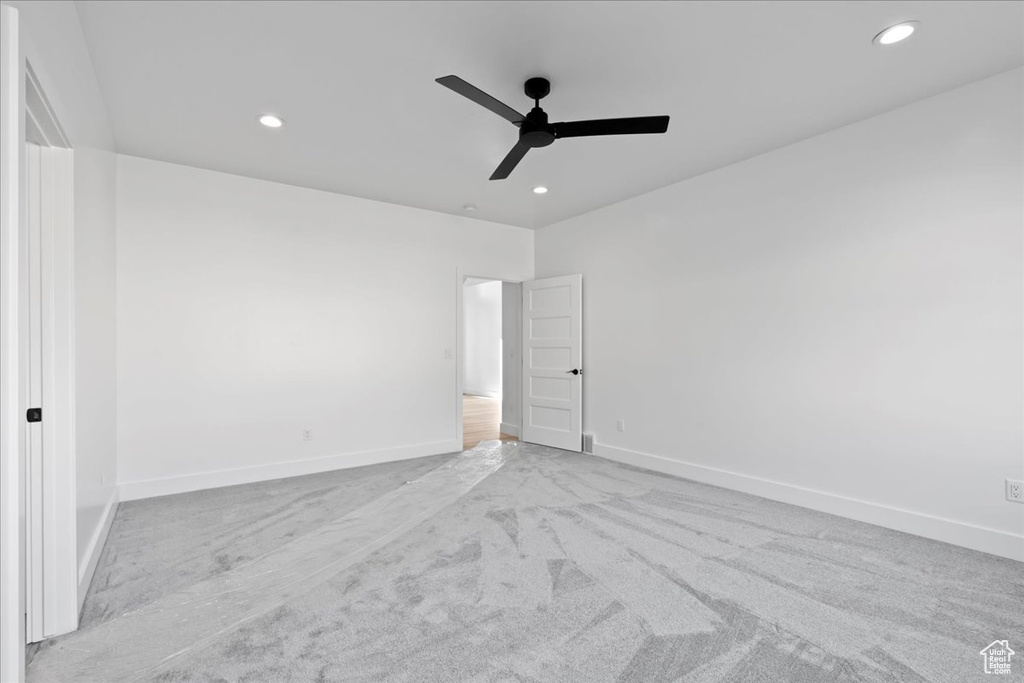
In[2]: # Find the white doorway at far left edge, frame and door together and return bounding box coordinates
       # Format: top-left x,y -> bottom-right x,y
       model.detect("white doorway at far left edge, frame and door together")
0,13 -> 78,681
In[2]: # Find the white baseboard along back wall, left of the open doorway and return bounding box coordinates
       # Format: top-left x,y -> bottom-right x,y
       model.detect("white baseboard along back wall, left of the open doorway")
118,440 -> 462,501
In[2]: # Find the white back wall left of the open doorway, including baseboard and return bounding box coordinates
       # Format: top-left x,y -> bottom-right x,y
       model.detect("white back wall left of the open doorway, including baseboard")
117,156 -> 534,498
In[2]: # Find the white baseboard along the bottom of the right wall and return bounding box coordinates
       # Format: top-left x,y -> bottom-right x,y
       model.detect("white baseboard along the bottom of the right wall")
594,443 -> 1024,562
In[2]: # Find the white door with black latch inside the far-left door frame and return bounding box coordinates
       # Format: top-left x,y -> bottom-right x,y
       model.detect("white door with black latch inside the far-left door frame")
23,139 -> 78,642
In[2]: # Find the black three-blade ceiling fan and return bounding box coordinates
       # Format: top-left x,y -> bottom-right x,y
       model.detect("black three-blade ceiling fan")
436,76 -> 669,180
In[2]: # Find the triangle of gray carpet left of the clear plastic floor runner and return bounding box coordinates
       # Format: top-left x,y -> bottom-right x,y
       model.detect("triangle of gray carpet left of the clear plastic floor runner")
81,456 -> 452,628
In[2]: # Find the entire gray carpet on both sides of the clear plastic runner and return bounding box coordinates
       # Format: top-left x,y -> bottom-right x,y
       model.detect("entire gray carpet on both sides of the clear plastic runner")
29,443 -> 1024,683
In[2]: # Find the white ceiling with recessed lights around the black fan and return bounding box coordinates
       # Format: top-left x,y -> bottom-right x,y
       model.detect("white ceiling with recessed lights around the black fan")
78,0 -> 1024,227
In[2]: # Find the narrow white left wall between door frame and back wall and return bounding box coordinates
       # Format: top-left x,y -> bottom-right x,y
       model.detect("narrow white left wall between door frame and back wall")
4,2 -> 117,601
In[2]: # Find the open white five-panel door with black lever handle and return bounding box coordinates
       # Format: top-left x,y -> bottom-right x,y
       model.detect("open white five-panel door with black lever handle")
520,275 -> 583,453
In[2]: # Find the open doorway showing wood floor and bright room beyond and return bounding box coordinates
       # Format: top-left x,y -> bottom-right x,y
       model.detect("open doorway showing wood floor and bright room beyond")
461,278 -> 520,450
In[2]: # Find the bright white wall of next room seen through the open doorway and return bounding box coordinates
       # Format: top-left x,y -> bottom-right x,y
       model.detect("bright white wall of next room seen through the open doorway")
462,280 -> 502,398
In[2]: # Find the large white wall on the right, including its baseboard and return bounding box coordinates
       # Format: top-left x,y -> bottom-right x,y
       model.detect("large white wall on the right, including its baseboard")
537,70 -> 1024,559
